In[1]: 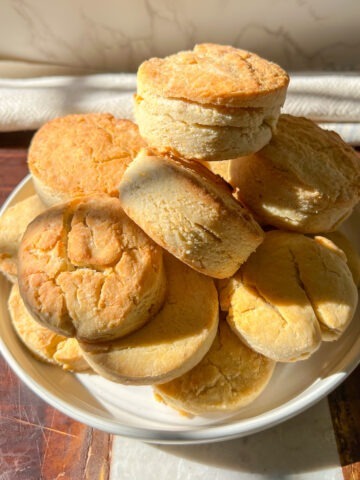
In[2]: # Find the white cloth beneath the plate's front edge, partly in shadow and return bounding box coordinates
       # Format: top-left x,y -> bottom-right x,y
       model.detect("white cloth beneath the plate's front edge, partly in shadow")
110,399 -> 344,480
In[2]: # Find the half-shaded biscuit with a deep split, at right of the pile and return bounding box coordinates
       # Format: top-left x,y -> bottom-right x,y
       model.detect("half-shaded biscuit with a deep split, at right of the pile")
220,230 -> 358,362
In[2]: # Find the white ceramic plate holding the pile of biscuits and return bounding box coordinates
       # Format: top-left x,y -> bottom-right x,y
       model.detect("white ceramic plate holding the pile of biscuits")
0,176 -> 360,443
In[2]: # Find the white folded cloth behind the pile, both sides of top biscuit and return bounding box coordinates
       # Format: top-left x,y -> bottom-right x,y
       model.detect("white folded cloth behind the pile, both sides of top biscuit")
0,73 -> 360,145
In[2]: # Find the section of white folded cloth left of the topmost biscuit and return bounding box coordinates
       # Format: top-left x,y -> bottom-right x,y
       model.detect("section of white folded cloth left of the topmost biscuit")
0,74 -> 136,131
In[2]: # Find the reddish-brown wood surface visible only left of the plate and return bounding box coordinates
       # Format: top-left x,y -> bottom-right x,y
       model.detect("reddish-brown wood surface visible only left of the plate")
0,132 -> 112,480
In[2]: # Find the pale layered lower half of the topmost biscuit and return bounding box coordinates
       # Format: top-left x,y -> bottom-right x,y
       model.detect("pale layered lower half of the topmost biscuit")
135,97 -> 280,160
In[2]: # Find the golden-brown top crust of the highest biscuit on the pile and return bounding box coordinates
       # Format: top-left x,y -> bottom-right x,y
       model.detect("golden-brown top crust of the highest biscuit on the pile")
137,43 -> 289,107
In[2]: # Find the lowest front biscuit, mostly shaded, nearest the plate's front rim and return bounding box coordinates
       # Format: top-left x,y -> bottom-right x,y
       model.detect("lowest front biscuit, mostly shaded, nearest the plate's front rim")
154,320 -> 275,415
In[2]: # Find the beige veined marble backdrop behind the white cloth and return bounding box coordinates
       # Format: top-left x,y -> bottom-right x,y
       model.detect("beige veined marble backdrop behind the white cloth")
0,0 -> 360,71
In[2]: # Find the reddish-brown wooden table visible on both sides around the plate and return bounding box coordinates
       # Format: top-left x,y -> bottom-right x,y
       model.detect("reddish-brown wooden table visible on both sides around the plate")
0,132 -> 360,480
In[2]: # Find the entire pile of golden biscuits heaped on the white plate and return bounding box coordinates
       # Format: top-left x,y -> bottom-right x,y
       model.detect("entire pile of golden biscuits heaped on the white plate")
0,44 -> 360,415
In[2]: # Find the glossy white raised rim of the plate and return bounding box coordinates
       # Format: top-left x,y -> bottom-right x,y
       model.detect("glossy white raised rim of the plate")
0,174 -> 360,444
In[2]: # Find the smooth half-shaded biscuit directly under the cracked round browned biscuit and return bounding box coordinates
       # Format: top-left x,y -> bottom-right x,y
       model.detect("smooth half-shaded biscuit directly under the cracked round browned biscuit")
80,255 -> 219,385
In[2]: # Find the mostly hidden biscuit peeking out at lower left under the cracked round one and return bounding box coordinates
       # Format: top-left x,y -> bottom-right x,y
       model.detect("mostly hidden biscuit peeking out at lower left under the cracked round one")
8,284 -> 90,372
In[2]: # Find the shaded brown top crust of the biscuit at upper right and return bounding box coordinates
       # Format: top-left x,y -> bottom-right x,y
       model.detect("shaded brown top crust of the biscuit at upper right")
254,114 -> 360,205
